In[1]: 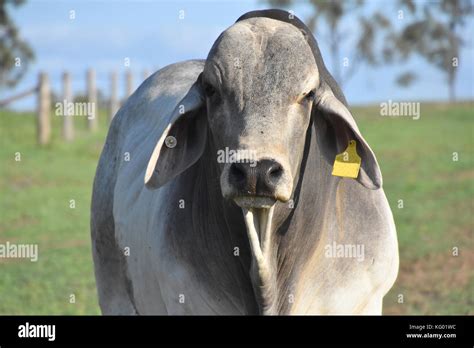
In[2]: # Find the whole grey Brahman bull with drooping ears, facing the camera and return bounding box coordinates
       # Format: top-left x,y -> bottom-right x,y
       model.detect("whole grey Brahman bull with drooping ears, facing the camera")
91,10 -> 399,314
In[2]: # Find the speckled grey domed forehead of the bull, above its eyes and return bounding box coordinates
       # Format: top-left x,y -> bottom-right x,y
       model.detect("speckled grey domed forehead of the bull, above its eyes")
204,18 -> 319,104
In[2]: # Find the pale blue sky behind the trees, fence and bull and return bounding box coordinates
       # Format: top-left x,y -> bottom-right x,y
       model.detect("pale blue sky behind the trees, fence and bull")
4,0 -> 474,109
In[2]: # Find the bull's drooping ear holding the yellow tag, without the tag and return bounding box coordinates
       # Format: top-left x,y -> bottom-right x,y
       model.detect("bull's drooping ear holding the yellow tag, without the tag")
313,83 -> 382,190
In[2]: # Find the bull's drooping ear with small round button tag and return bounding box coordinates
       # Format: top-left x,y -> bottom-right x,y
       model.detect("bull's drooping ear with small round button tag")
145,79 -> 207,188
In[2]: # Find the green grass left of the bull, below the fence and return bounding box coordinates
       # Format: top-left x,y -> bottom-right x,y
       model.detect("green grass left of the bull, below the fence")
0,111 -> 106,314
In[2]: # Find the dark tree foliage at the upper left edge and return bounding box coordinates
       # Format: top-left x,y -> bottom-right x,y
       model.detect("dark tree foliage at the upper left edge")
0,0 -> 34,88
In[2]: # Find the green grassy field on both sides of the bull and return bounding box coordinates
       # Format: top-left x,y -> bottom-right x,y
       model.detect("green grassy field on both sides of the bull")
0,103 -> 474,314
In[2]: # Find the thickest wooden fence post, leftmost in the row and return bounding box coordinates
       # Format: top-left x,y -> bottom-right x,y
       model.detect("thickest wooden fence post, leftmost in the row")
36,72 -> 51,145
